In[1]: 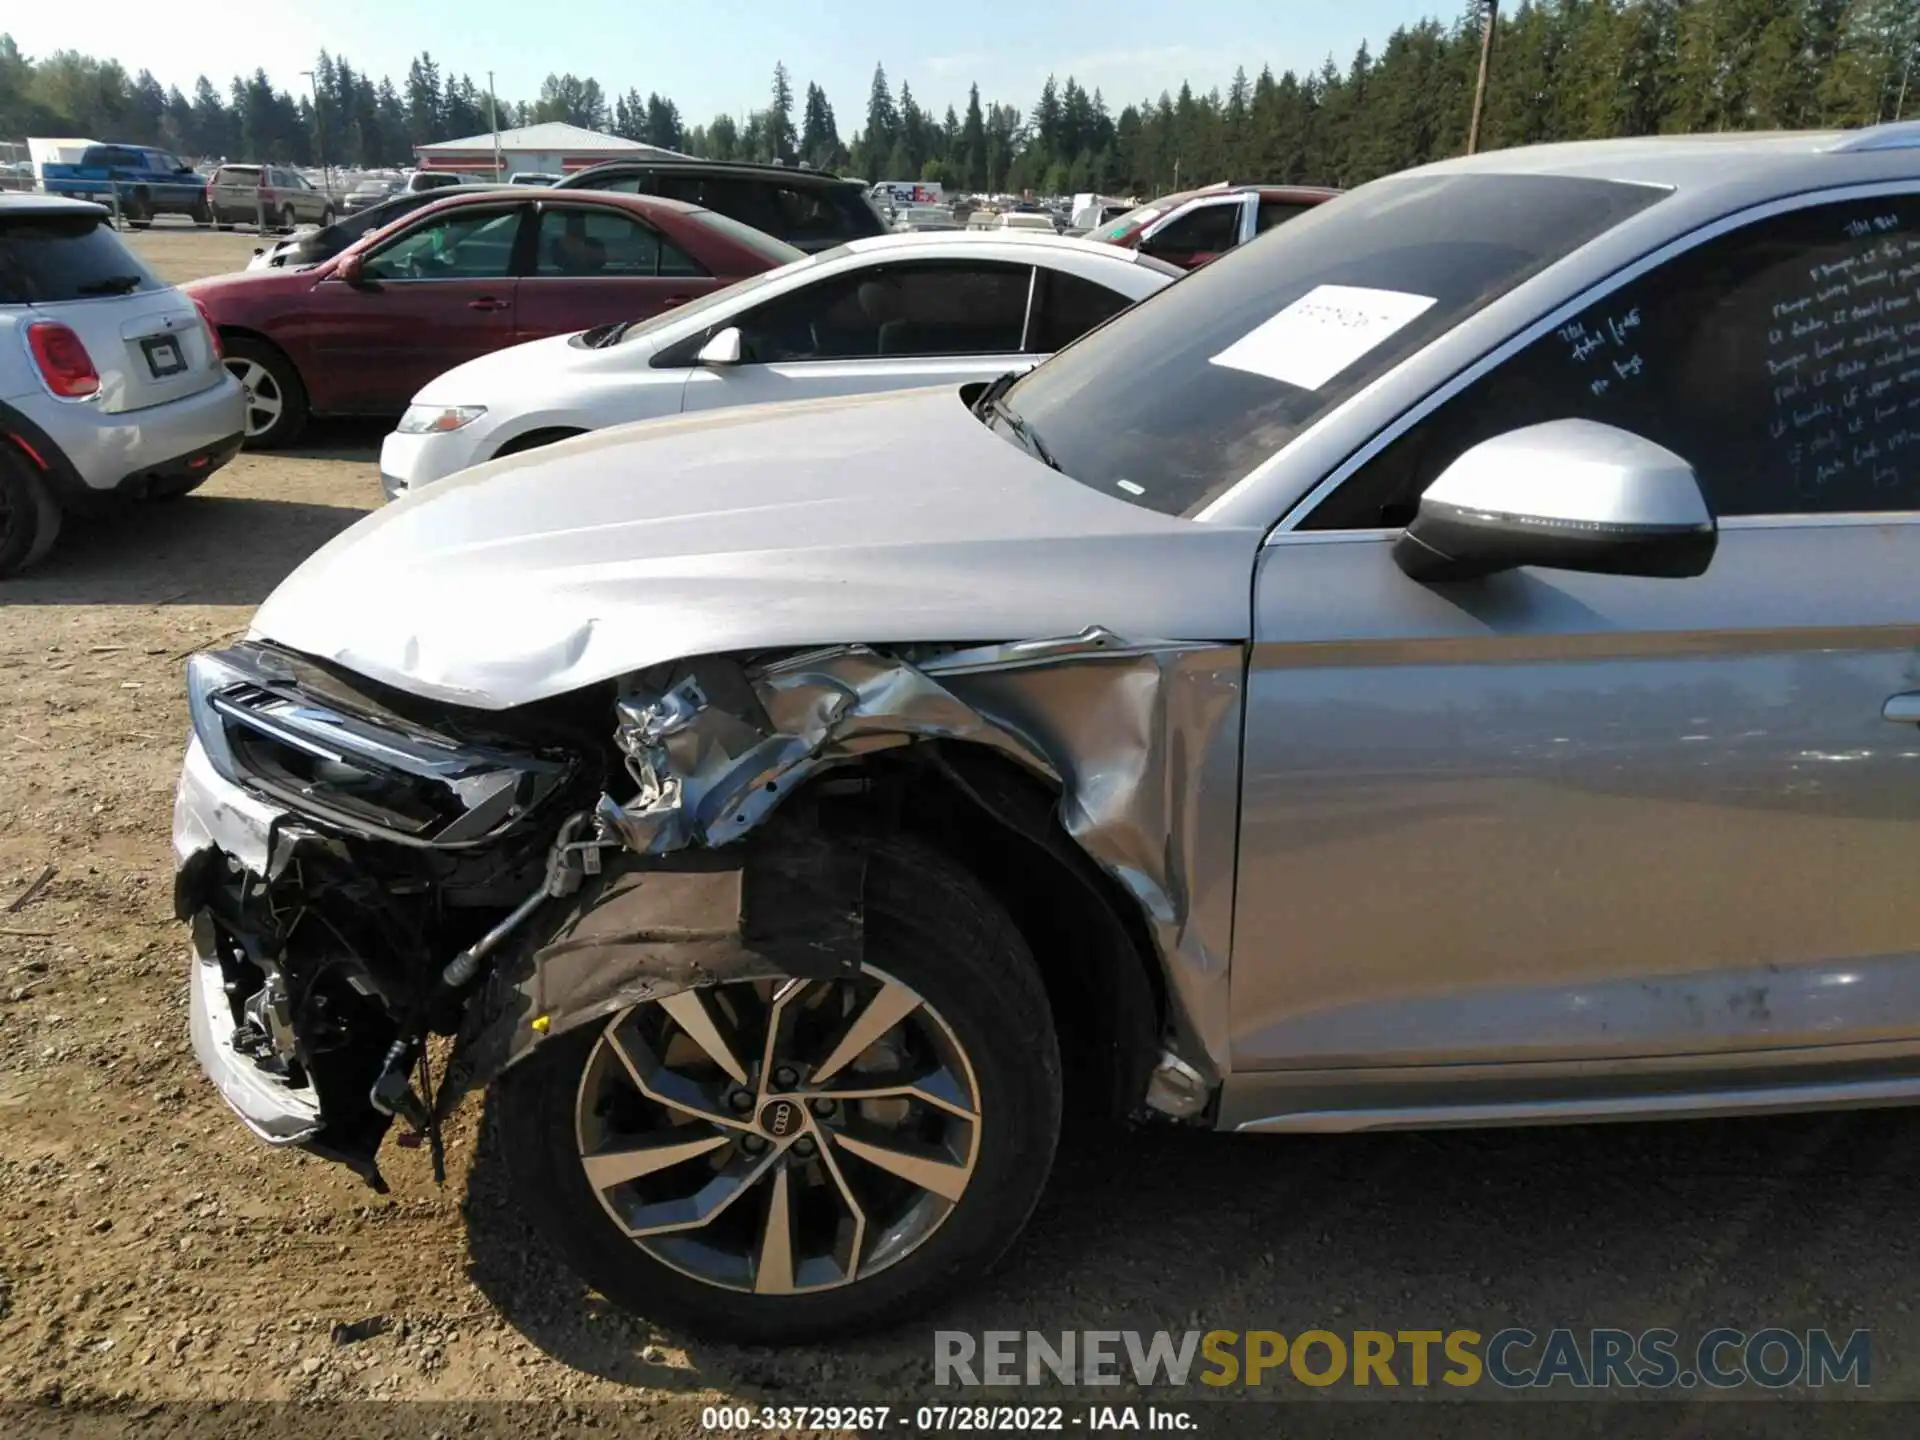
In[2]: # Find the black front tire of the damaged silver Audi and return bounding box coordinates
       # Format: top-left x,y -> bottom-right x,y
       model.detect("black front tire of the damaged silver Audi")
493,841 -> 1062,1344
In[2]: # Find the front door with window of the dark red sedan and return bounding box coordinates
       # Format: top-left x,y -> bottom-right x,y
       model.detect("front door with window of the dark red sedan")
309,204 -> 528,415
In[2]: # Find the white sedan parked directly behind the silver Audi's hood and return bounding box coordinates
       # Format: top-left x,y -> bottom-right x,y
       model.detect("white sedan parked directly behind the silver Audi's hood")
380,230 -> 1185,499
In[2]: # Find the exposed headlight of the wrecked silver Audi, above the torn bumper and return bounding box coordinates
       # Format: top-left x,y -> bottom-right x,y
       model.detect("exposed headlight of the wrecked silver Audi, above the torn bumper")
186,645 -> 574,847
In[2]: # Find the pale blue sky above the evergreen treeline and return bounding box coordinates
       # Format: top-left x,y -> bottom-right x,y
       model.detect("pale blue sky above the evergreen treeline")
11,0 -> 1465,125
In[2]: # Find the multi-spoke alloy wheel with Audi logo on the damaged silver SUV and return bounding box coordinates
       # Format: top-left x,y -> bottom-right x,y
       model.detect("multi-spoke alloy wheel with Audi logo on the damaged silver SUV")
574,968 -> 981,1294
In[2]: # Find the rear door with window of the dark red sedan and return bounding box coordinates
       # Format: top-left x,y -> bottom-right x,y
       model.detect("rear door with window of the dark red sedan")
515,202 -> 720,340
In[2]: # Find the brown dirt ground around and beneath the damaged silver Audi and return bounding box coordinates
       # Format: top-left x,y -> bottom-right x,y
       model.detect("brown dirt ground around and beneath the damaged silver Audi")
0,230 -> 1920,1432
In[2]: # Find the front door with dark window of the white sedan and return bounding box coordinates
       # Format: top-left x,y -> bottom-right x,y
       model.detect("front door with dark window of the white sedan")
684,261 -> 1039,414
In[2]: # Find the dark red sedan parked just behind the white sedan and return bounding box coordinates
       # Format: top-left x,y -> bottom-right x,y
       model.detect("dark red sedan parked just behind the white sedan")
184,190 -> 803,445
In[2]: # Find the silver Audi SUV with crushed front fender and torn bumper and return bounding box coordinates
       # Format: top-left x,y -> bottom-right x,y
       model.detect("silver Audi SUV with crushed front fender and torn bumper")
175,125 -> 1920,1342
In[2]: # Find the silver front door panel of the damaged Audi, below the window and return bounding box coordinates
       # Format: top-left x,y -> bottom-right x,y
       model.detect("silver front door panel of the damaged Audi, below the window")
1233,515 -> 1920,1069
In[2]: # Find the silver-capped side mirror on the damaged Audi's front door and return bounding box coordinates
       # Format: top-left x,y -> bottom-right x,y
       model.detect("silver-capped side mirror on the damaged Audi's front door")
1394,420 -> 1718,584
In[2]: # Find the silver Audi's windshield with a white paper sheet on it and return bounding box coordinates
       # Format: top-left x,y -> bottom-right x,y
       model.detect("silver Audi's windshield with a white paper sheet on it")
1002,173 -> 1667,515
